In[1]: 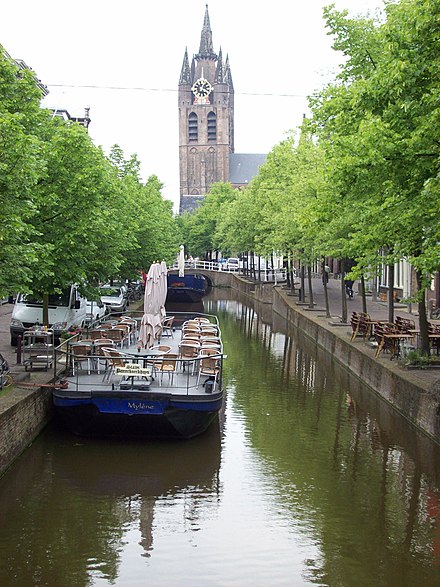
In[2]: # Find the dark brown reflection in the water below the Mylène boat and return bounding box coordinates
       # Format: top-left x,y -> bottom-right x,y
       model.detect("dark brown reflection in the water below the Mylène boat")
0,425 -> 221,586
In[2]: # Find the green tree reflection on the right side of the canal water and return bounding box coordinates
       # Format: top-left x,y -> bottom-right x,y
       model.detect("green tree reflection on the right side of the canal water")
208,300 -> 440,585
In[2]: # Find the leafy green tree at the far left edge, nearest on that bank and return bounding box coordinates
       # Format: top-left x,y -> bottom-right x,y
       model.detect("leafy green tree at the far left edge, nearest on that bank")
0,46 -> 47,297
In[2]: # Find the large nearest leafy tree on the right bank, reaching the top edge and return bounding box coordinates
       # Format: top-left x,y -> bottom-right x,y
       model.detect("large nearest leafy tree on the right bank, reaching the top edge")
313,0 -> 440,352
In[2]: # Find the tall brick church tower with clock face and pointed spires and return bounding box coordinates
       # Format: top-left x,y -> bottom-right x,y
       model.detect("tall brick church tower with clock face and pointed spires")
178,5 -> 234,214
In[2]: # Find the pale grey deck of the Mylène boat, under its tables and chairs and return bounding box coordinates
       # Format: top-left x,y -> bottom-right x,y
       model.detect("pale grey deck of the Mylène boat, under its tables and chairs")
57,314 -> 223,399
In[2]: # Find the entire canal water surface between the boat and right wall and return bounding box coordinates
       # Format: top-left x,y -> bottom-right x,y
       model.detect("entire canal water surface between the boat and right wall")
0,290 -> 440,587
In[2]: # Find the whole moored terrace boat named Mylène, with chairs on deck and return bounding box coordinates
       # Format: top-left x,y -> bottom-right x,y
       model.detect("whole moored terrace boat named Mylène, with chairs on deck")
53,313 -> 225,438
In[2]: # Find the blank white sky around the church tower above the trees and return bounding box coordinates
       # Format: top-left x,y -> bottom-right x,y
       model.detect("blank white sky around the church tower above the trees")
0,0 -> 382,211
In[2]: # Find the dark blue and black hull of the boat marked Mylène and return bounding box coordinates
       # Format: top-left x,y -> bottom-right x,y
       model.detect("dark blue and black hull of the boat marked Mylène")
53,391 -> 223,438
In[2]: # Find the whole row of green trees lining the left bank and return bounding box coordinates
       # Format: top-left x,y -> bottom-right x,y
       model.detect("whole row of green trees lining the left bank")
0,46 -> 180,297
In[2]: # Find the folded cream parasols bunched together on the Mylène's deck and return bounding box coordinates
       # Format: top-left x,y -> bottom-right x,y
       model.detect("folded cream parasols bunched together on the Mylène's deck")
139,262 -> 167,348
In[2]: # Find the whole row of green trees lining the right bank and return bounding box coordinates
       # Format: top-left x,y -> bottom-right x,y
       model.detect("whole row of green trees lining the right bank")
181,0 -> 440,352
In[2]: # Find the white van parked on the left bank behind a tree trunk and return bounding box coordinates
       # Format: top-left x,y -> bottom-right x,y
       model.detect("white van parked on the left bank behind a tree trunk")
10,285 -> 87,346
